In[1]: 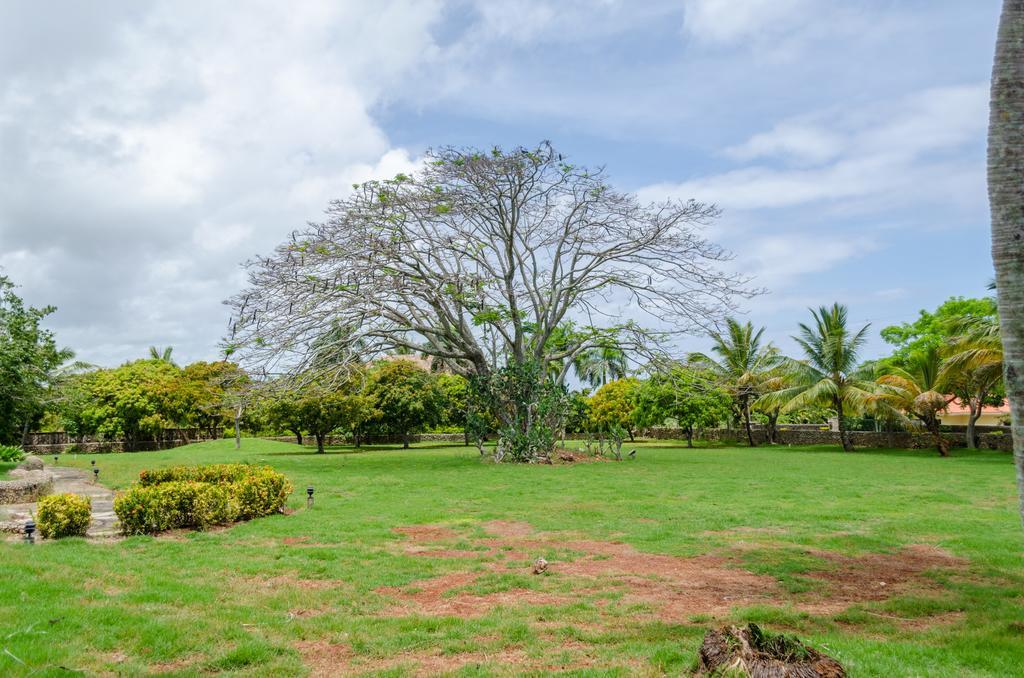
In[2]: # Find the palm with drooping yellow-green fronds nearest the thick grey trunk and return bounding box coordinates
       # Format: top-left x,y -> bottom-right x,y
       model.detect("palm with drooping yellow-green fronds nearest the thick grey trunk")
939,316 -> 1002,450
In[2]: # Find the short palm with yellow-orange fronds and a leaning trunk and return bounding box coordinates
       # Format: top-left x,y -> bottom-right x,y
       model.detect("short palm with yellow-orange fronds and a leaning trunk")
878,347 -> 955,457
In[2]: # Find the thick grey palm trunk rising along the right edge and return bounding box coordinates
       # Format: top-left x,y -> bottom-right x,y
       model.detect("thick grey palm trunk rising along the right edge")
988,0 -> 1024,532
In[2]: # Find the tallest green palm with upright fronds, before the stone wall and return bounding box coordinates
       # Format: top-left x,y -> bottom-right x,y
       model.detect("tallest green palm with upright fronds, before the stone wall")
764,303 -> 876,452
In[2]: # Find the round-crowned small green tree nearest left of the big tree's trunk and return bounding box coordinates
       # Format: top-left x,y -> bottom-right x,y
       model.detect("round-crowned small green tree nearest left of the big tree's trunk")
368,358 -> 443,448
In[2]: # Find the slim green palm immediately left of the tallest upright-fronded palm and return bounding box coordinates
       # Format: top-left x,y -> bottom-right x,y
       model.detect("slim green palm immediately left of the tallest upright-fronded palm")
689,317 -> 782,448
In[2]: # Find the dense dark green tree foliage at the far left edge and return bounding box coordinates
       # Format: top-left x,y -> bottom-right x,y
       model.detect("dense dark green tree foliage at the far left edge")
0,274 -> 73,443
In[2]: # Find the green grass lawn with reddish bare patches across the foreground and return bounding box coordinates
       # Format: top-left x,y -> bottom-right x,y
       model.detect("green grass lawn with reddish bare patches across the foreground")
0,439 -> 1024,676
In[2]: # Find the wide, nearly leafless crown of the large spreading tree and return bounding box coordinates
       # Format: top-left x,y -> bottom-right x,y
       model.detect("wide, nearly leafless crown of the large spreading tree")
227,143 -> 750,457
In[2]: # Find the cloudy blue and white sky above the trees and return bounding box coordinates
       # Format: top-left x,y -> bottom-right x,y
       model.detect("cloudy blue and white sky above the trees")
0,0 -> 1000,366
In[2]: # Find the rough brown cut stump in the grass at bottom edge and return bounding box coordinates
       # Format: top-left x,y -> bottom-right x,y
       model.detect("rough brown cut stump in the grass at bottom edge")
697,624 -> 846,678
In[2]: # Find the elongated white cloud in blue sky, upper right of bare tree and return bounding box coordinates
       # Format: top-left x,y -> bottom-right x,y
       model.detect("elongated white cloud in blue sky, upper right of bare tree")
641,84 -> 988,210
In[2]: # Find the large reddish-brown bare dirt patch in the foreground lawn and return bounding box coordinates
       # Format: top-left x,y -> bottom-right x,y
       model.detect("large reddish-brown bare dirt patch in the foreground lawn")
379,520 -> 966,622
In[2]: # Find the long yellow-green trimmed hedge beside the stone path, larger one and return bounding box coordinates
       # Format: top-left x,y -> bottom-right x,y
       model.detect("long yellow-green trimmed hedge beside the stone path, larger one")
114,464 -> 292,535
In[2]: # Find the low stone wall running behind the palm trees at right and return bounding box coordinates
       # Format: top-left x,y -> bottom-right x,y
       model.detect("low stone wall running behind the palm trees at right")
645,424 -> 1013,452
